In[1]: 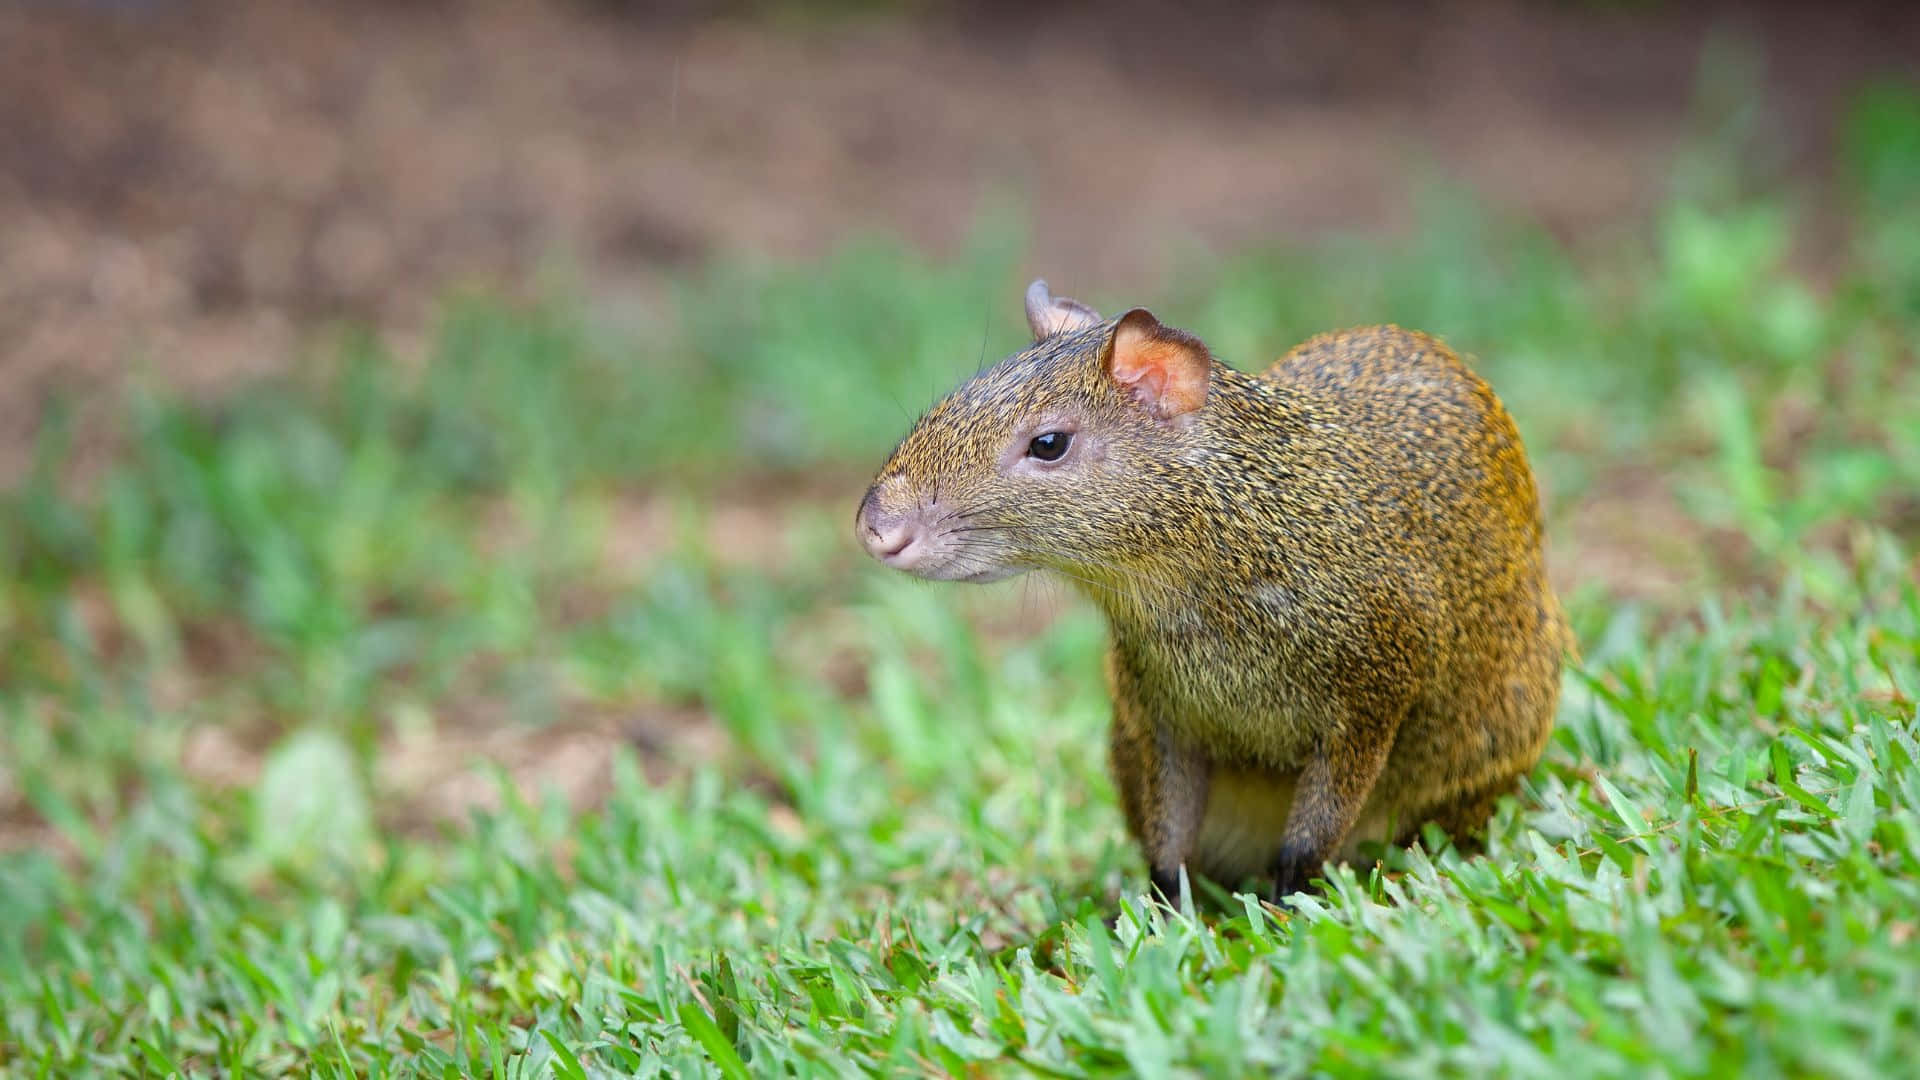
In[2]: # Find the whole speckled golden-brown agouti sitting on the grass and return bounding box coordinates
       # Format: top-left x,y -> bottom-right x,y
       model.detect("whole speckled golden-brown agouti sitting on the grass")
856,281 -> 1572,899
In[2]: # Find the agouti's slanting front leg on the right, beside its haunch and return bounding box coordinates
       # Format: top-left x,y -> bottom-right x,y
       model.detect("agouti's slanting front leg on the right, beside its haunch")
1273,724 -> 1394,903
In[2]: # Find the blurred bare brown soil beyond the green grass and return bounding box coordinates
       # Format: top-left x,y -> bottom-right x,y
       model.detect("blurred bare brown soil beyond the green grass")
0,0 -> 1920,477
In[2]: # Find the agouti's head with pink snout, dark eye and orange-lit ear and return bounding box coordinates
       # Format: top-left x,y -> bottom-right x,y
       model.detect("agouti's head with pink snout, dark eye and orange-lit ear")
854,281 -> 1223,582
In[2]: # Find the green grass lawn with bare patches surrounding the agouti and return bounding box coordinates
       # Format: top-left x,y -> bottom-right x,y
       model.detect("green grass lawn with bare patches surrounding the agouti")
0,82 -> 1920,1076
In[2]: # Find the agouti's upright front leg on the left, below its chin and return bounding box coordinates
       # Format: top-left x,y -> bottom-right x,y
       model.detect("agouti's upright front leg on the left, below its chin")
1108,698 -> 1212,903
